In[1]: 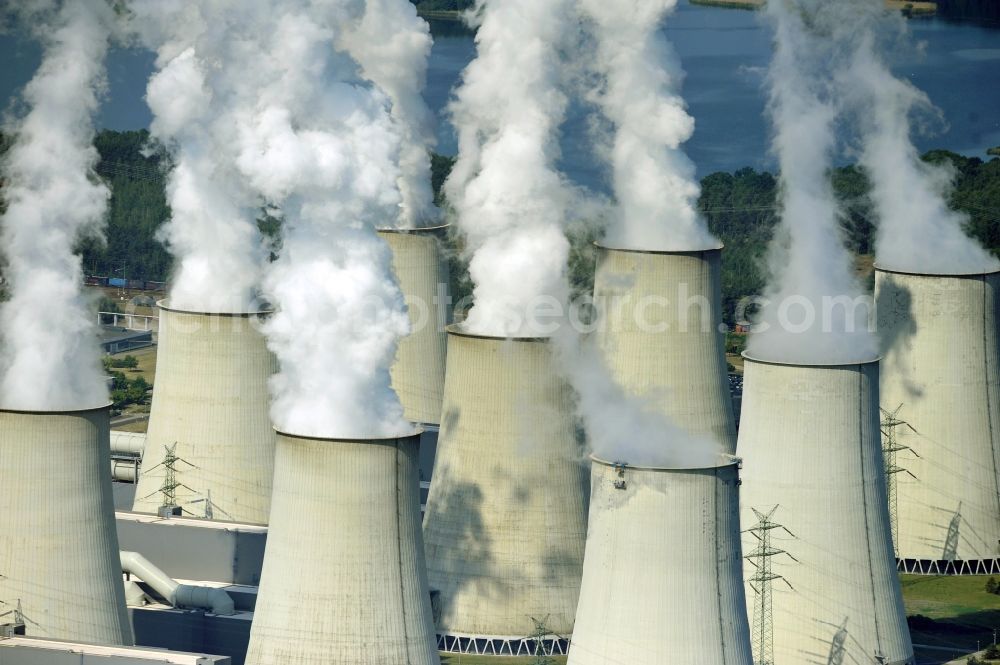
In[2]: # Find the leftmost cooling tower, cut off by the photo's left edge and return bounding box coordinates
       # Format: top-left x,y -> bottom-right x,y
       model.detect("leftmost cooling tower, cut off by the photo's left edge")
0,406 -> 132,645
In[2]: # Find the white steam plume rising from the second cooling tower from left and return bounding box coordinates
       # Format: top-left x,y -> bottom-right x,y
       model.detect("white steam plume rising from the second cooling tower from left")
130,0 -> 267,312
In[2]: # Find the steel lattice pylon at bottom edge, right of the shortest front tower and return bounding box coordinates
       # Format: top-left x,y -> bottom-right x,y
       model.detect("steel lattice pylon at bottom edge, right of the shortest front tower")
743,506 -> 798,665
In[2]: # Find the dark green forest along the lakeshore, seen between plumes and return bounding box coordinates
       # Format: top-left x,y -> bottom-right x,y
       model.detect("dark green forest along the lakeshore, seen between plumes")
0,131 -> 1000,324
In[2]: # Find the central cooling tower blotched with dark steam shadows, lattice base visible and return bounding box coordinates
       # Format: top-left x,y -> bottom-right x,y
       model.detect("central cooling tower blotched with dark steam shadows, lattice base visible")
424,326 -> 587,655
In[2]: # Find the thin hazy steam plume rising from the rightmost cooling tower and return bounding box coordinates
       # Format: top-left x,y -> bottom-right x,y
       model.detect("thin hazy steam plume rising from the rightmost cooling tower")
831,0 -> 1000,274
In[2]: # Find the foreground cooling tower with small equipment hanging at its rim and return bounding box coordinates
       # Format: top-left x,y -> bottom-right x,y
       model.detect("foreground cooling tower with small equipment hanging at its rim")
569,458 -> 753,665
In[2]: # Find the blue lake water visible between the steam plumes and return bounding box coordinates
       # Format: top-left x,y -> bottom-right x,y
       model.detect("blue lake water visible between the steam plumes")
0,1 -> 1000,187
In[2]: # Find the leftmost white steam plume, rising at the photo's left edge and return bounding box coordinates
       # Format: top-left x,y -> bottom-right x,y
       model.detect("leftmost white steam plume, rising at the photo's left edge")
0,0 -> 115,410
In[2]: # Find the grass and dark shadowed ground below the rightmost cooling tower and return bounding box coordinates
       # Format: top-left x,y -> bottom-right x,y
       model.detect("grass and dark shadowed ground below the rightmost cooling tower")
900,575 -> 1000,652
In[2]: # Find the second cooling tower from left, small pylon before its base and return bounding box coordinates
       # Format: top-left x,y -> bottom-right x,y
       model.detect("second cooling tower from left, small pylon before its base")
134,302 -> 277,524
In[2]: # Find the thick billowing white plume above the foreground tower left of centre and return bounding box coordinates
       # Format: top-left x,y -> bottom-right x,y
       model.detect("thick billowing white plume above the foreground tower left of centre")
230,0 -> 412,438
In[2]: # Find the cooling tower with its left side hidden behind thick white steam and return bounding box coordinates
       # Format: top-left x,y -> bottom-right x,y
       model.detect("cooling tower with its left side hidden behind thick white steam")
379,227 -> 448,425
